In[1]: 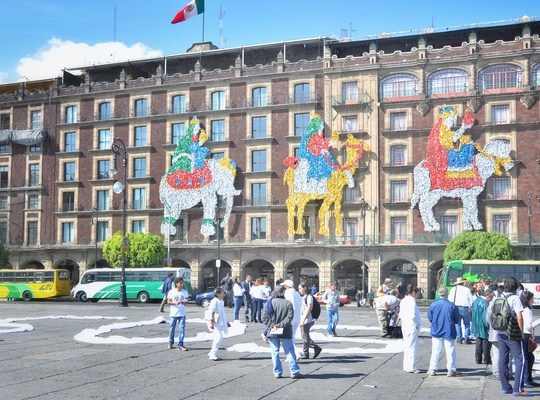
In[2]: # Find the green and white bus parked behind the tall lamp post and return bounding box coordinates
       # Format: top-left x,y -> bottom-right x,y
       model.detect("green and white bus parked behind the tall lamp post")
71,268 -> 191,303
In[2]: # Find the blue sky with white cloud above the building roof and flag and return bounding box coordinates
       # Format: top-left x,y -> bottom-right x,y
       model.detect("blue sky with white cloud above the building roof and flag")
0,0 -> 540,84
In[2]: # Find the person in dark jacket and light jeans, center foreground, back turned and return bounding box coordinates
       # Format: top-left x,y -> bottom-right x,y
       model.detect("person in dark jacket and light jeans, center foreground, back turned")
262,286 -> 304,379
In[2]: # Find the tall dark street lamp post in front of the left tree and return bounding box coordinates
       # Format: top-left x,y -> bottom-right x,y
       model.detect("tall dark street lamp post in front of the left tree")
111,137 -> 129,307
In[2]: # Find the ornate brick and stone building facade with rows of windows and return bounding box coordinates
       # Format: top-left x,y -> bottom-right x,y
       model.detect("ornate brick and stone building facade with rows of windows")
0,21 -> 540,295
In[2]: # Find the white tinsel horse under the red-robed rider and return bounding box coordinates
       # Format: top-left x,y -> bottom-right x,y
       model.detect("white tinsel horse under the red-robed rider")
411,140 -> 514,232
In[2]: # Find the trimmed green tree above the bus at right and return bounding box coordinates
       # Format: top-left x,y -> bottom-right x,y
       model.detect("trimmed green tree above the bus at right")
443,231 -> 514,263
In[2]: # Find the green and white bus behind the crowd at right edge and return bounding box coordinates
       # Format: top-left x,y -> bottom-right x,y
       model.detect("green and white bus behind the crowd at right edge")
437,260 -> 540,306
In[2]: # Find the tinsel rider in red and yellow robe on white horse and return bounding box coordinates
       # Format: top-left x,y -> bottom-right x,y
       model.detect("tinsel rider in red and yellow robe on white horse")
425,106 -> 482,190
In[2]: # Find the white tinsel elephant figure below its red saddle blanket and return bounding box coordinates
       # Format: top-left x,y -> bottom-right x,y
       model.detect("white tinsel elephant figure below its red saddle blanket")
159,158 -> 241,236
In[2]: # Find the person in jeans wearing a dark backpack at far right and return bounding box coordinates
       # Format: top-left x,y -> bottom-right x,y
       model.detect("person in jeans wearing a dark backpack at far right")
489,276 -> 529,396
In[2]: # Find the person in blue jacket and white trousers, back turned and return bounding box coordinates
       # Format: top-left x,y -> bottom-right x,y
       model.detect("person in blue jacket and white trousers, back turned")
427,287 -> 460,377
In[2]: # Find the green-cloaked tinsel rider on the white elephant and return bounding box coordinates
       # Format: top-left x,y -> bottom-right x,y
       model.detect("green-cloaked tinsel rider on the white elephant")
168,116 -> 208,174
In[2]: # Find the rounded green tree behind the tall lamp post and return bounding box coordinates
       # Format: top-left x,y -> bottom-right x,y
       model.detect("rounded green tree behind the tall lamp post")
103,231 -> 167,268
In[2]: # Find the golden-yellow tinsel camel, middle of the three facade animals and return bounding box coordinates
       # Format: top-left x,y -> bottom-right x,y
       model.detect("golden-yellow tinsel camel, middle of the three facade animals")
283,134 -> 369,236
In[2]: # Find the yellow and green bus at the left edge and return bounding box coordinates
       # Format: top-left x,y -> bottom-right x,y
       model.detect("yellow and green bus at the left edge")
0,269 -> 71,301
